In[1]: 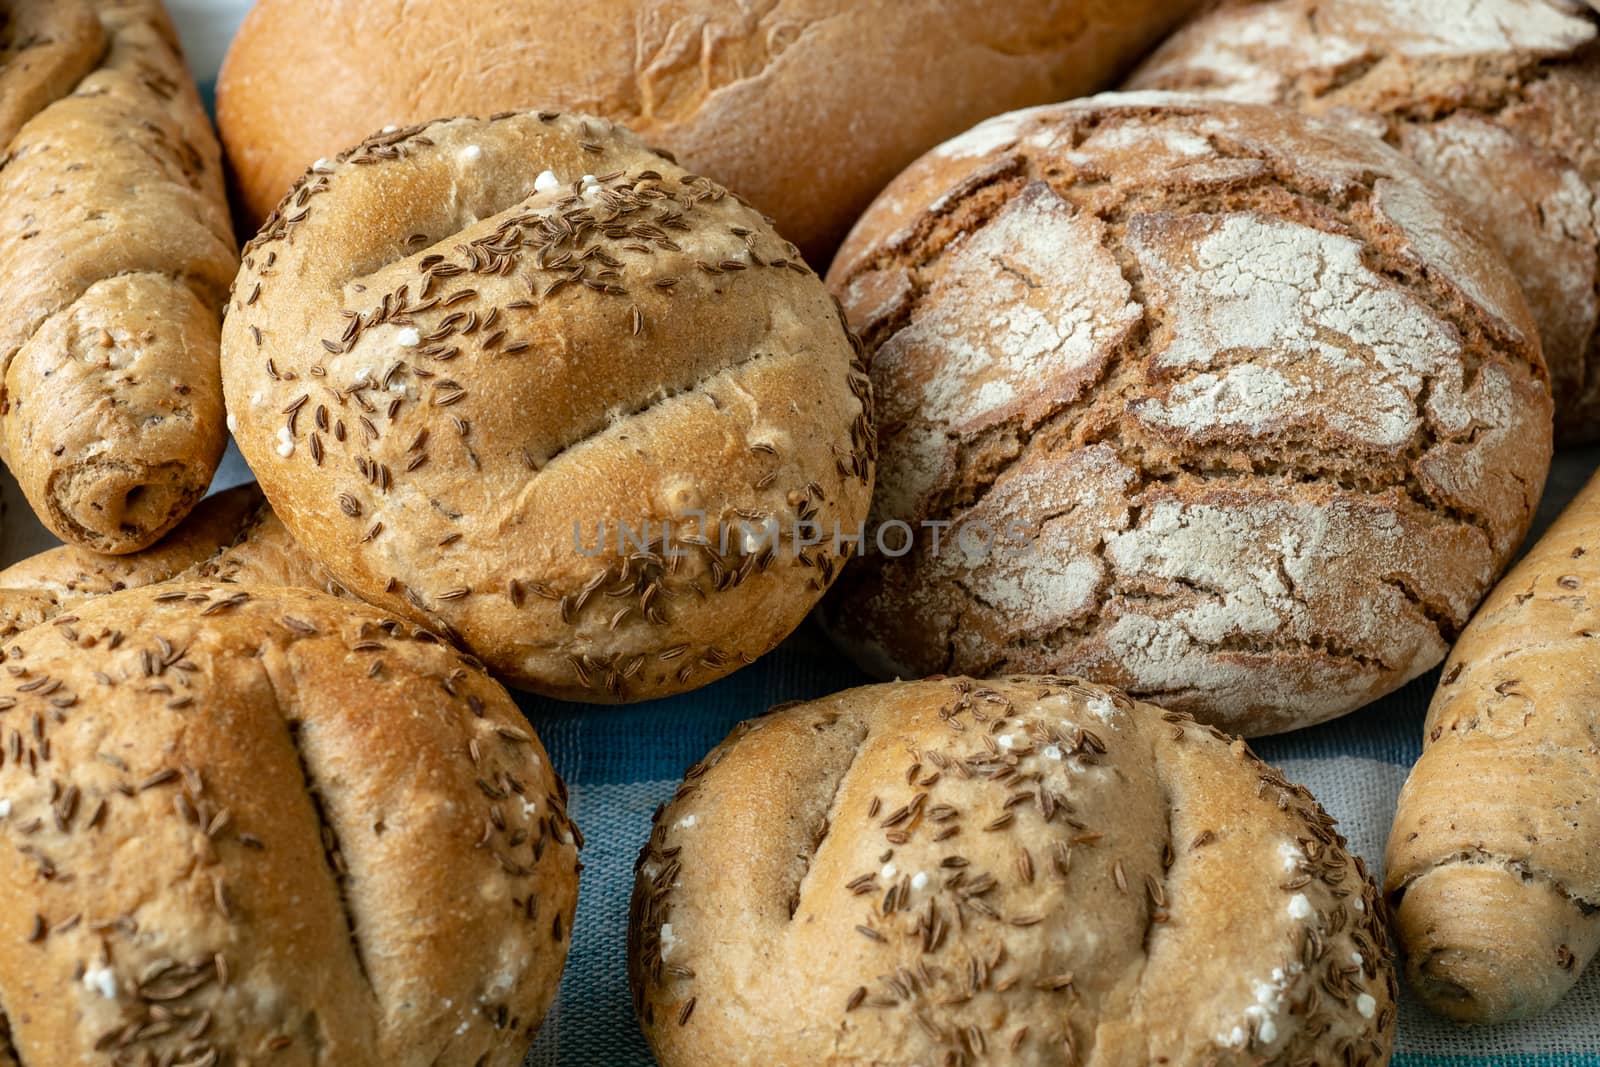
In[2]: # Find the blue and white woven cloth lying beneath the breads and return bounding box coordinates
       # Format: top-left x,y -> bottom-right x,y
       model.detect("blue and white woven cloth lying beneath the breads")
137,0 -> 1600,1067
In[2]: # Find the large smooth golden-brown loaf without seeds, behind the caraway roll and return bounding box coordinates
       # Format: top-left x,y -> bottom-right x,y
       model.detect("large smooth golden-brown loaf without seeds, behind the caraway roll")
218,0 -> 1197,262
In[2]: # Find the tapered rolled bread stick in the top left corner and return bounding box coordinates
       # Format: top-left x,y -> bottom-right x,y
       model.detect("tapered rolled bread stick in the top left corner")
0,0 -> 238,553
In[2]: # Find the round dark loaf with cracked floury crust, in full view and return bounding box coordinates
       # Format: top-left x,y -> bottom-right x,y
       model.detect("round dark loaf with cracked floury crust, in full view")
824,94 -> 1550,734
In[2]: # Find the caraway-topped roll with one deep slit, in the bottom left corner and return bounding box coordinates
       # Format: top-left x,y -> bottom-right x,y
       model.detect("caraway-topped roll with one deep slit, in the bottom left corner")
0,584 -> 581,1067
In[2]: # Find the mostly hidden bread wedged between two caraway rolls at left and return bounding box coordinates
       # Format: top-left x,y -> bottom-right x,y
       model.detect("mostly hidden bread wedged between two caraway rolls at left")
0,485 -> 328,638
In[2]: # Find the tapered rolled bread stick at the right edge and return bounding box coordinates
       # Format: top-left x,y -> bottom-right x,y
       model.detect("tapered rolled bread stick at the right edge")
1386,478 -> 1600,1022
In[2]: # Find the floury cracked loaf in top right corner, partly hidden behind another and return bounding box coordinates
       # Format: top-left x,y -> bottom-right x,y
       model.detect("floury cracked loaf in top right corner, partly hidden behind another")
1131,0 -> 1600,442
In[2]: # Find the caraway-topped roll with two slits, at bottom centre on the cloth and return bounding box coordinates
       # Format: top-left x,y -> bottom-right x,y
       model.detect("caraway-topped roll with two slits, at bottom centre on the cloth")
629,677 -> 1395,1067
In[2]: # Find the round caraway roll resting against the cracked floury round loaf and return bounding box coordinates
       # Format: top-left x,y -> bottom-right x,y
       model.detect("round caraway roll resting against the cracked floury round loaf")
222,112 -> 875,701
